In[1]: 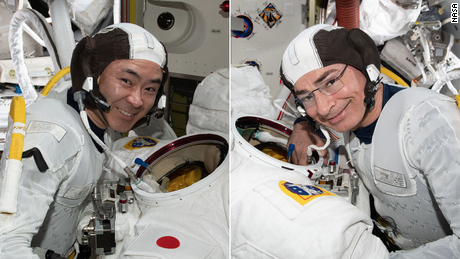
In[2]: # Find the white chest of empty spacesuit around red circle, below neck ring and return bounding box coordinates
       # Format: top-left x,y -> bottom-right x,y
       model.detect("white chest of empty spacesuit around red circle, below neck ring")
117,171 -> 229,259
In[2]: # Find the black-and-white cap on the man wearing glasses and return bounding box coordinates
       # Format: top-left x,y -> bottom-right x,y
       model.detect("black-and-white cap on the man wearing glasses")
280,24 -> 380,91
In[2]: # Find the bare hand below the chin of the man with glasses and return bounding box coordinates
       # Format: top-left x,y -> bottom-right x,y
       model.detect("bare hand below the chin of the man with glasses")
286,121 -> 328,165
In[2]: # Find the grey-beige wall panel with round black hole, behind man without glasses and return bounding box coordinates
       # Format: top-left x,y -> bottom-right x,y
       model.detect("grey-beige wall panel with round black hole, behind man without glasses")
142,0 -> 229,76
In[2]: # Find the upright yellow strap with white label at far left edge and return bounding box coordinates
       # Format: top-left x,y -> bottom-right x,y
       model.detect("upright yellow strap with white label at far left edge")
8,96 -> 26,161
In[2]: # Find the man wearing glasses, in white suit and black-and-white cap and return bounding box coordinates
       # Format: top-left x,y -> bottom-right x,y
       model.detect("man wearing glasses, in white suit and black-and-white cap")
280,24 -> 460,258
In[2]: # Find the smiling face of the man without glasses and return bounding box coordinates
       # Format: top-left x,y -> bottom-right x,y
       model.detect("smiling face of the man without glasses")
88,59 -> 163,132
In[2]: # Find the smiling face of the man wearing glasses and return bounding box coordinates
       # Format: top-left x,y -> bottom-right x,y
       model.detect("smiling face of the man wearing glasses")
294,64 -> 374,132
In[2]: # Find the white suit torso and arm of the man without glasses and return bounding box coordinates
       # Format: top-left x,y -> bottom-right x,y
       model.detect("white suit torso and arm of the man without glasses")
0,99 -> 104,258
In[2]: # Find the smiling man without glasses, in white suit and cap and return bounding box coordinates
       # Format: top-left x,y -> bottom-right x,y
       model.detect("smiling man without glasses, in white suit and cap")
0,24 -> 168,258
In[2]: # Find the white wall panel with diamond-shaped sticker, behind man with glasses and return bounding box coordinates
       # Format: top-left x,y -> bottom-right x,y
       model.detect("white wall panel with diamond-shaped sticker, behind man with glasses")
231,0 -> 305,99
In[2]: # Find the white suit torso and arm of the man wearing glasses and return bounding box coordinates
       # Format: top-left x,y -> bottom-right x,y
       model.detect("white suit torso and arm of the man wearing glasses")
344,89 -> 460,258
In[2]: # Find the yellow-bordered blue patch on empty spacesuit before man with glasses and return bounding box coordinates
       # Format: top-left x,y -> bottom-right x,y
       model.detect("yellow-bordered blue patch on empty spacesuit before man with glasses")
279,181 -> 336,206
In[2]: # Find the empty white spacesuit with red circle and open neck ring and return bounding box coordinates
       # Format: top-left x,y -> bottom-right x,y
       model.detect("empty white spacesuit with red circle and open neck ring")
105,133 -> 229,259
